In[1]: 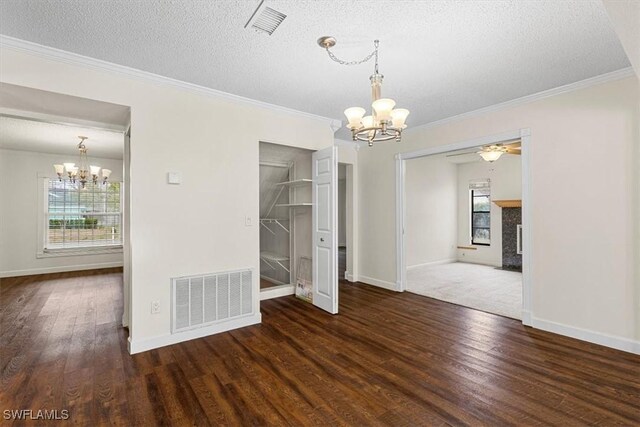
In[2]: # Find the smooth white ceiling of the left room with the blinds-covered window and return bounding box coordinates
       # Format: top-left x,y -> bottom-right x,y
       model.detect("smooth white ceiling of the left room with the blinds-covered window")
0,117 -> 124,162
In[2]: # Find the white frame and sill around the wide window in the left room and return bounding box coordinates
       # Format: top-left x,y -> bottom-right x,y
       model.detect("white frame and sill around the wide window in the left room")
36,176 -> 124,258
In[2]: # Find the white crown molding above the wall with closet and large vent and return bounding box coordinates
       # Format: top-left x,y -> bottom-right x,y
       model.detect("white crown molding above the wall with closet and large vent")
0,34 -> 341,128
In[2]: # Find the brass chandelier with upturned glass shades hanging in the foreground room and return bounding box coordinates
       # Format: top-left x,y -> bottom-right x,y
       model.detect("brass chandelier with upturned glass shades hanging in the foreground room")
318,36 -> 409,147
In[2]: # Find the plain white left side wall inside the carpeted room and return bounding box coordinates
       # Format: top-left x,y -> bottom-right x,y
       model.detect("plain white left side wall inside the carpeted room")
405,157 -> 458,268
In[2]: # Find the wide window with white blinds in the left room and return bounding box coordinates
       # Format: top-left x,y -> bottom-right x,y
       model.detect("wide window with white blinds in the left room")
44,179 -> 122,252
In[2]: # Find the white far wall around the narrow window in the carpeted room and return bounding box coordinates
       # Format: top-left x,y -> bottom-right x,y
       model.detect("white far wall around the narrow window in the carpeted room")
457,155 -> 522,267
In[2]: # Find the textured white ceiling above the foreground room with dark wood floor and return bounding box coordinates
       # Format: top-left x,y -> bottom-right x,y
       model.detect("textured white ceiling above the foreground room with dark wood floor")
0,0 -> 629,125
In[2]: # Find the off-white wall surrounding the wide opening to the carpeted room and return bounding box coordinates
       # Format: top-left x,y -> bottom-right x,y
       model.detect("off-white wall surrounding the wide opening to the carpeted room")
358,77 -> 640,351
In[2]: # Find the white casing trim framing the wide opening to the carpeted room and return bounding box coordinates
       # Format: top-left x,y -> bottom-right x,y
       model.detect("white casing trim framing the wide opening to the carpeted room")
395,128 -> 533,325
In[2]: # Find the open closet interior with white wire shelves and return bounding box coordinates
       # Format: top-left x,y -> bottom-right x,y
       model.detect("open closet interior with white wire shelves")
259,142 -> 312,299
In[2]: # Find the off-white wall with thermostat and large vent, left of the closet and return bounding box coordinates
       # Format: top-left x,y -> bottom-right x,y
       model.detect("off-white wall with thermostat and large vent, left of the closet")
0,44 -> 333,351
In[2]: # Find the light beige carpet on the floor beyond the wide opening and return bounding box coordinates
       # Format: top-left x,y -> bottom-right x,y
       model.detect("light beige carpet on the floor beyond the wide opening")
407,262 -> 522,319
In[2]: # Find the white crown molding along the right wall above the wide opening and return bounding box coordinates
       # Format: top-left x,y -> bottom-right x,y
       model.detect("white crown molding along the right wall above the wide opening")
405,67 -> 635,132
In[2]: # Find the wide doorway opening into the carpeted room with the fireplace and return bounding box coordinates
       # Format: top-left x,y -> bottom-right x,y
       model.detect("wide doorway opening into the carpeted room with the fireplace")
396,130 -> 531,324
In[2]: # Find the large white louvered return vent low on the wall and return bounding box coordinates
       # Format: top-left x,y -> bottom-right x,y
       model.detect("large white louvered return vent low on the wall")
171,270 -> 254,333
